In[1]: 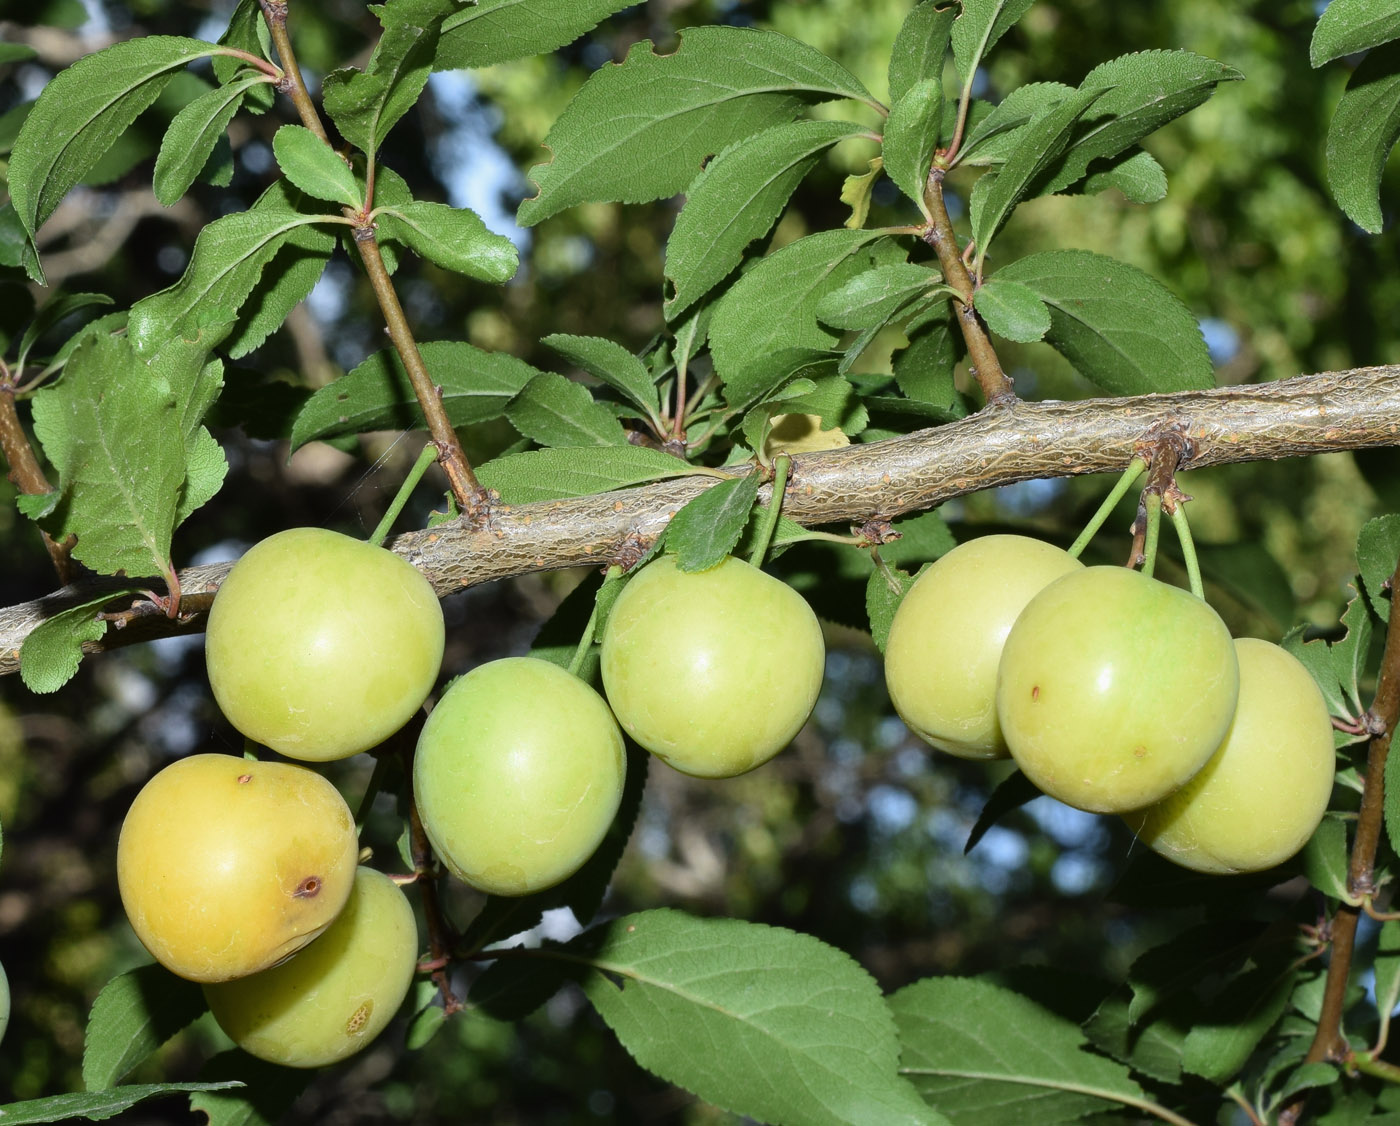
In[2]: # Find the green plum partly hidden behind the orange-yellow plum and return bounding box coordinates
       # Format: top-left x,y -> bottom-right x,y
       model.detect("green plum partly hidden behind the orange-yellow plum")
204,868 -> 419,1067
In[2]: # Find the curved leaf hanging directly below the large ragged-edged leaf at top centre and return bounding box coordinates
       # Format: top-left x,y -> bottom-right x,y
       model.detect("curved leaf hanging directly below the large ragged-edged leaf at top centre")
665,120 -> 867,319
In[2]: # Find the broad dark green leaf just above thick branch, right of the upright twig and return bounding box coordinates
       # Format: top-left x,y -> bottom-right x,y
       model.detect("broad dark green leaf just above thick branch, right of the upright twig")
997,251 -> 1215,395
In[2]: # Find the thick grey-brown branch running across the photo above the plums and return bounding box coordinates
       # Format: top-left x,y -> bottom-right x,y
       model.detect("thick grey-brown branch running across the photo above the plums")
0,367 -> 1400,675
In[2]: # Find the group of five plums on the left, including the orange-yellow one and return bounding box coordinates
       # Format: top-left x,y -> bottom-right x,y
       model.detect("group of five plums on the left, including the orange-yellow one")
118,528 -> 825,1067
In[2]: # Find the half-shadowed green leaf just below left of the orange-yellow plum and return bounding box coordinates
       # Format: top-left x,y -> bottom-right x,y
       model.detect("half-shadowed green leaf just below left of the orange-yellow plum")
83,965 -> 209,1091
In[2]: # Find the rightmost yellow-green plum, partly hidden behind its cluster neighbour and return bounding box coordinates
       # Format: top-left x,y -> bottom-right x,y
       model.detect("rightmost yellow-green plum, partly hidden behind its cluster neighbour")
1124,637 -> 1337,874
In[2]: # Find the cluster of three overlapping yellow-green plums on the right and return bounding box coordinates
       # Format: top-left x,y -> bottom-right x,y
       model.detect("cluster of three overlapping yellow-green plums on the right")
885,535 -> 1336,873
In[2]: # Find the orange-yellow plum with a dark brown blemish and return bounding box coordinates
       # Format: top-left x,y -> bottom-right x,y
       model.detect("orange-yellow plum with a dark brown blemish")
116,755 -> 360,982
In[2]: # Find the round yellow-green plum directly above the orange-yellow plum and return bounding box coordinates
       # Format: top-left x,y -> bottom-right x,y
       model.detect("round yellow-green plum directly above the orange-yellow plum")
206,528 -> 444,762
